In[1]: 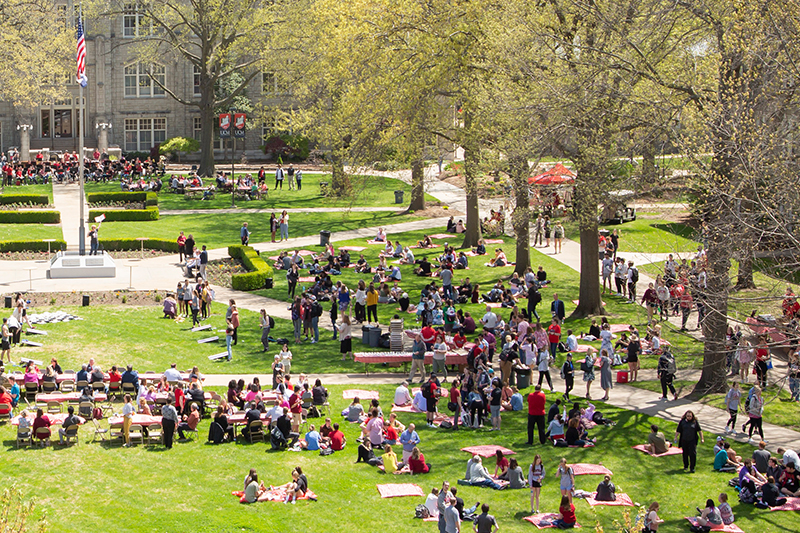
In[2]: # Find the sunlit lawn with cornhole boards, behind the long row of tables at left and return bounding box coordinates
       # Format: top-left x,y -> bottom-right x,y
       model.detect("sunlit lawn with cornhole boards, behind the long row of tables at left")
7,304 -> 385,374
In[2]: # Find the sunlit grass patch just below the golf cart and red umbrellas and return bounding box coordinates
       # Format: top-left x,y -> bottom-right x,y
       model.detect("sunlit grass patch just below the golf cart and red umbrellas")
563,217 -> 697,254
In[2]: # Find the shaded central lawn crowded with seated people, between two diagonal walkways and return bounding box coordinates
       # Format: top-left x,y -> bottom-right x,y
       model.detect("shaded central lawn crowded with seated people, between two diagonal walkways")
253,226 -> 702,368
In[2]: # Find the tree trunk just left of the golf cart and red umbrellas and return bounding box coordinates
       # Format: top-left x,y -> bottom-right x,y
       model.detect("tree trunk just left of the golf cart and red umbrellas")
570,181 -> 605,318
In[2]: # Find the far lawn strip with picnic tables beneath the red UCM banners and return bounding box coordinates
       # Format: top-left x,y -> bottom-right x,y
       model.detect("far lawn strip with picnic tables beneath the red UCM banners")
86,172 -> 436,210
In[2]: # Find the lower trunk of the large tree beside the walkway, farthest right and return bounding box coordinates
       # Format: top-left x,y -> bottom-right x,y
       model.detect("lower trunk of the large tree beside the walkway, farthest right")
692,216 -> 730,396
